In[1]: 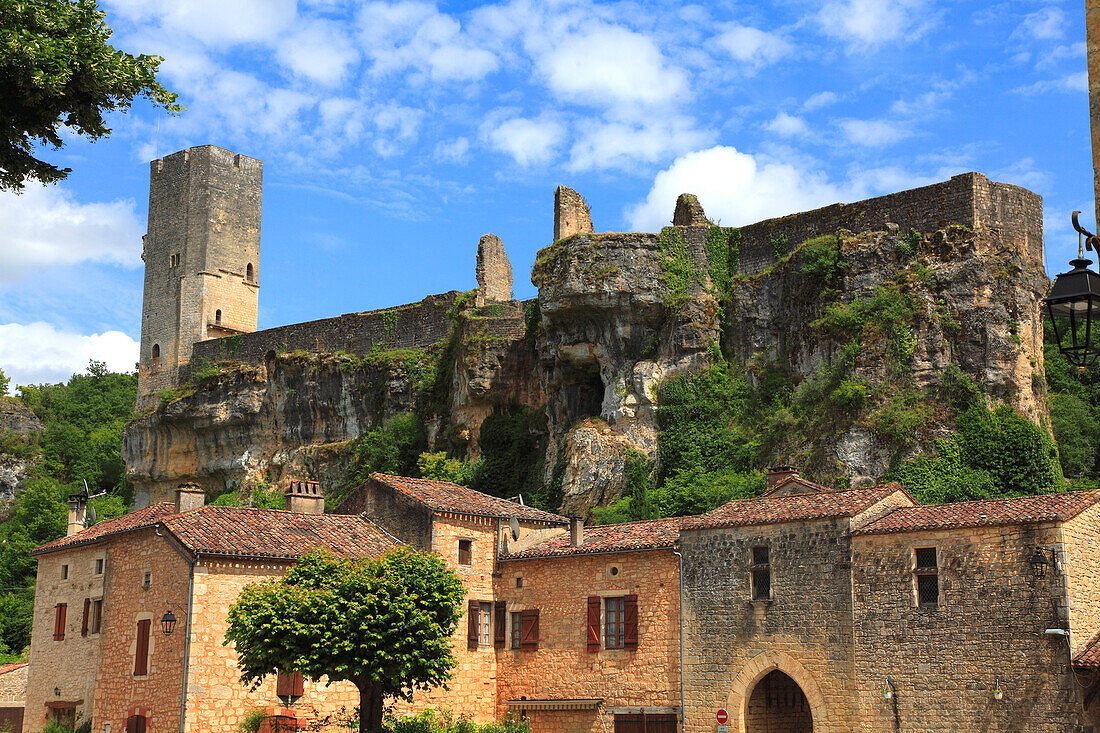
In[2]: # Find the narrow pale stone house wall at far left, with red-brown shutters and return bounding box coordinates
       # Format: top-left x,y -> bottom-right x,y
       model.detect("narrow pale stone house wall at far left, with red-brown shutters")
23,546 -> 105,733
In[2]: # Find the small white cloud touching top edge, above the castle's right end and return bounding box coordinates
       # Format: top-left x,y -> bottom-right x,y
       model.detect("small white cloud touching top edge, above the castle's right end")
817,0 -> 926,52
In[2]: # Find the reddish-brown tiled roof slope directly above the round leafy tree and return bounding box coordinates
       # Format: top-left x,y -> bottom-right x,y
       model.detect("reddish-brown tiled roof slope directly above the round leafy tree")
164,505 -> 396,559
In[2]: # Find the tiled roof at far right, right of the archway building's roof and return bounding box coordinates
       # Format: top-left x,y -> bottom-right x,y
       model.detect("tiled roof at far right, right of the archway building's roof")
853,491 -> 1100,535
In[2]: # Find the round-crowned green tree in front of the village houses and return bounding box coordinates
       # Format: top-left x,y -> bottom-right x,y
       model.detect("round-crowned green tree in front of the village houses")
224,547 -> 465,733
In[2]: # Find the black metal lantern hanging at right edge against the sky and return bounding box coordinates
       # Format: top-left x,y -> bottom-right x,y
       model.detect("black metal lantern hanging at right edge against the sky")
1043,211 -> 1100,369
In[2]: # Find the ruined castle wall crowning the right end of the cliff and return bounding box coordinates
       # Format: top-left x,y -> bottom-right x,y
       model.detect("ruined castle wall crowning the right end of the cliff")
739,173 -> 1043,275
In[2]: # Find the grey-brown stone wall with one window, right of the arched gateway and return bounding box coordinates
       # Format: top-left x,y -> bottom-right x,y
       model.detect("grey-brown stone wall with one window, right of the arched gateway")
851,525 -> 1084,733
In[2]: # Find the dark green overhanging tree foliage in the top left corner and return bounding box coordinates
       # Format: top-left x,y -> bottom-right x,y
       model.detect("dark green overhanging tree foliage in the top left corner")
0,0 -> 183,192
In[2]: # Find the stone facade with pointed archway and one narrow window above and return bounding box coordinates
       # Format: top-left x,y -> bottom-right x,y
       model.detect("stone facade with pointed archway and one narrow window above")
681,519 -> 857,733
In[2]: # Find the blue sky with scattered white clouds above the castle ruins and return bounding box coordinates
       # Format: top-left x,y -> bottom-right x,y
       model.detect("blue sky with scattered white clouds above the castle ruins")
0,0 -> 1092,383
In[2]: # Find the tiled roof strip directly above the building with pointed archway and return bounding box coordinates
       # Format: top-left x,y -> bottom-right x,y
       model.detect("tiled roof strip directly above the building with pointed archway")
682,483 -> 904,530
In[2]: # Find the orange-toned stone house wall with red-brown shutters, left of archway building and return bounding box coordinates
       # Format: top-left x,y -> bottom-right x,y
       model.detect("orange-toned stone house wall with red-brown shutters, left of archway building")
497,550 -> 680,733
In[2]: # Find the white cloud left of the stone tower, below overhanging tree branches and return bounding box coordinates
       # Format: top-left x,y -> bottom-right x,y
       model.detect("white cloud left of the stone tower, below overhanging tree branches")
0,185 -> 143,283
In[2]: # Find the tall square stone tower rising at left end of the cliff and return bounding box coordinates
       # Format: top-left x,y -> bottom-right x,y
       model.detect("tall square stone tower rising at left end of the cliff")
138,145 -> 263,411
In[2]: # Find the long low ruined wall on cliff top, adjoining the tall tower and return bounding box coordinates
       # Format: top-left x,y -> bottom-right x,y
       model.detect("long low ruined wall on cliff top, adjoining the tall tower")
183,291 -> 460,376
